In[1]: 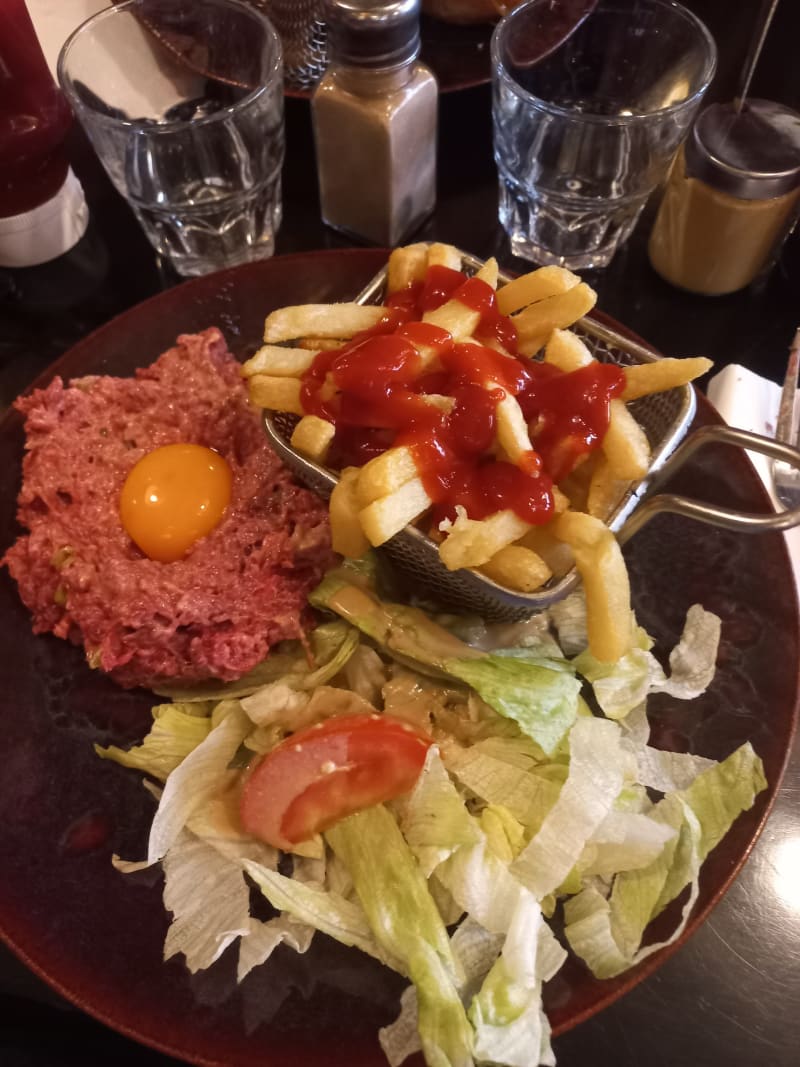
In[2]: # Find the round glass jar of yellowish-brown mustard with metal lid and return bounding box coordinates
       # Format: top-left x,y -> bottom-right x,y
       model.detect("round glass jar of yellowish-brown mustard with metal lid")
649,100 -> 800,296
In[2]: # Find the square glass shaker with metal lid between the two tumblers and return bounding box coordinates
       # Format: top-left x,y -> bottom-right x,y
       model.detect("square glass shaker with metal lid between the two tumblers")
311,0 -> 438,244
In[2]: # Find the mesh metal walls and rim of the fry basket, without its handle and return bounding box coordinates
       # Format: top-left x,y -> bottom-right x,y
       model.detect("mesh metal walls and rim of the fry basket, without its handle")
263,247 -> 695,622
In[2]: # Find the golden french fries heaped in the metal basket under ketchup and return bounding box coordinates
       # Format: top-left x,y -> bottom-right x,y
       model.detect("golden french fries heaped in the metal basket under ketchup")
253,244 -> 710,618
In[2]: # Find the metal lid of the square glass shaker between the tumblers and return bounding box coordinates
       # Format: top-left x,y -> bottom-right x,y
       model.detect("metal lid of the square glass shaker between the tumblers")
325,0 -> 420,69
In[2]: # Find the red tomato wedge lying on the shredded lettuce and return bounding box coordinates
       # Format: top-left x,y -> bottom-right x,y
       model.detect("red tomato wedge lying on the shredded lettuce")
239,714 -> 432,849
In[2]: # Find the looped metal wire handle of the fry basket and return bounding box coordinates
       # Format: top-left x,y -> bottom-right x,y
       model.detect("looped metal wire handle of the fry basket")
617,426 -> 800,543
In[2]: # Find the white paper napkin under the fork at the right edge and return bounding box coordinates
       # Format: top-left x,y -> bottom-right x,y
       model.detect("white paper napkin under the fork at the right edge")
708,364 -> 800,588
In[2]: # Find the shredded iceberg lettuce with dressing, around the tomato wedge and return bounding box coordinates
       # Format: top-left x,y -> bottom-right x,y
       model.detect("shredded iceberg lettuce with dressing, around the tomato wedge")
97,566 -> 766,1067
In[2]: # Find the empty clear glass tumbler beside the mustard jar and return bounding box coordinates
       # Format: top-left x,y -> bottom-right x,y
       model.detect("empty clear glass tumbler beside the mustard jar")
492,0 -> 717,269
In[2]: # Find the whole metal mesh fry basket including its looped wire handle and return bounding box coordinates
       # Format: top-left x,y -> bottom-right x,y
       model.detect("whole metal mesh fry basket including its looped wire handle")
263,252 -> 800,622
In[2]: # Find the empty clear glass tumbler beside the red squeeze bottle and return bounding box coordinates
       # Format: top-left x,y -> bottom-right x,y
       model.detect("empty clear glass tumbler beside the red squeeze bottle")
58,0 -> 284,275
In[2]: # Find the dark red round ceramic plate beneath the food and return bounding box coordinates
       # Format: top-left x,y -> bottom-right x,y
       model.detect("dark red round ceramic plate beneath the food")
0,250 -> 798,1067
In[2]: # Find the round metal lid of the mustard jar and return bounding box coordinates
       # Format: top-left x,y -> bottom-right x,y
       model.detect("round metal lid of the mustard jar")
686,100 -> 800,200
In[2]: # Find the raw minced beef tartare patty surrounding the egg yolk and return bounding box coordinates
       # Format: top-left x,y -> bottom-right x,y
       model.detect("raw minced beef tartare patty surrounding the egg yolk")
2,329 -> 331,686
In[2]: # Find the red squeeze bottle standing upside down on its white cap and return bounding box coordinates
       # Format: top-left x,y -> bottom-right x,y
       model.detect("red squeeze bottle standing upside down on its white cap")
0,0 -> 87,267
